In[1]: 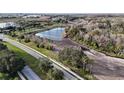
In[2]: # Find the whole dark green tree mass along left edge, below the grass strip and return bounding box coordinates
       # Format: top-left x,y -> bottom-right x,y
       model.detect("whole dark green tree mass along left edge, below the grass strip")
0,42 -> 25,80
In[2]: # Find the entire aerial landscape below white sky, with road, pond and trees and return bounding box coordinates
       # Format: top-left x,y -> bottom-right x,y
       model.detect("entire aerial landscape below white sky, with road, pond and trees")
0,13 -> 124,80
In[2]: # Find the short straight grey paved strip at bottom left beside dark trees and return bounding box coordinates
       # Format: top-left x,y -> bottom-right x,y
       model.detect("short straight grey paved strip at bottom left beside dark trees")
21,66 -> 41,80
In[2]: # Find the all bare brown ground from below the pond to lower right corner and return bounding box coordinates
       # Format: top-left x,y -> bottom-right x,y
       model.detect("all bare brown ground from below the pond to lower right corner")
38,38 -> 124,80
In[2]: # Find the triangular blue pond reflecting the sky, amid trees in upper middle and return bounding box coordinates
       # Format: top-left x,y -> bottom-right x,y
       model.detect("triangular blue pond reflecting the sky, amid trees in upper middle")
36,27 -> 65,41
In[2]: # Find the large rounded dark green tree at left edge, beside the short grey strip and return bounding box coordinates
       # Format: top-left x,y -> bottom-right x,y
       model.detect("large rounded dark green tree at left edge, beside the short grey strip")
0,54 -> 25,75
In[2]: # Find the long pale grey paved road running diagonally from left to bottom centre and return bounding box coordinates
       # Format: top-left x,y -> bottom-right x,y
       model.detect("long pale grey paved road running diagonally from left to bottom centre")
4,37 -> 84,80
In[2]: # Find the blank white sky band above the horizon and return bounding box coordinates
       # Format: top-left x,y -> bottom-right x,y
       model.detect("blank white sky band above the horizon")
0,0 -> 124,13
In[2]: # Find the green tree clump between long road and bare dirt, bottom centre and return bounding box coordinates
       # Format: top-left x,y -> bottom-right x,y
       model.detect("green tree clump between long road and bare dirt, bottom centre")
59,48 -> 95,79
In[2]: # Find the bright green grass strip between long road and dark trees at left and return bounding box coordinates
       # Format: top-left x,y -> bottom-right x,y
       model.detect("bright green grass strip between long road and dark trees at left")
4,42 -> 46,79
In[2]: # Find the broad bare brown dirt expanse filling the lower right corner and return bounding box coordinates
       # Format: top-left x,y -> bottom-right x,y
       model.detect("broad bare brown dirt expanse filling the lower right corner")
84,51 -> 124,80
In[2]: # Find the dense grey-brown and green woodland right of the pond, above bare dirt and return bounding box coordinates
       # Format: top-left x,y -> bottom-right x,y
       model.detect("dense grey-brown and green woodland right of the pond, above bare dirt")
66,17 -> 124,58
